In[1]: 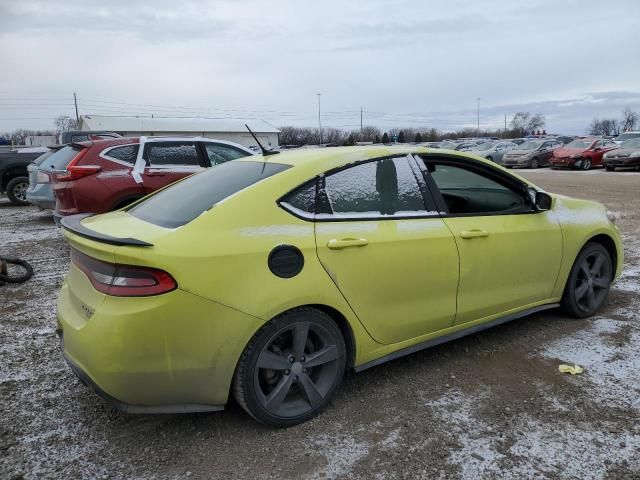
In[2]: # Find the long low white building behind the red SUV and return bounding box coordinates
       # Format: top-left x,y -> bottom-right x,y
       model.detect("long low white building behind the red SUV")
79,115 -> 280,148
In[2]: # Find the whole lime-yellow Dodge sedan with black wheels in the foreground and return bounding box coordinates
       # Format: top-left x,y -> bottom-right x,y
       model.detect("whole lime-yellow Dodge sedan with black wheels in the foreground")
58,146 -> 623,426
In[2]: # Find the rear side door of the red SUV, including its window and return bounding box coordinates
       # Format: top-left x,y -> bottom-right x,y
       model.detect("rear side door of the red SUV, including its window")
141,140 -> 206,193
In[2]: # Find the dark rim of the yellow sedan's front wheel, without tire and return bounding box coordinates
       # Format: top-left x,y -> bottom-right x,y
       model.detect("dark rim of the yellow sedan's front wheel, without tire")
574,252 -> 611,312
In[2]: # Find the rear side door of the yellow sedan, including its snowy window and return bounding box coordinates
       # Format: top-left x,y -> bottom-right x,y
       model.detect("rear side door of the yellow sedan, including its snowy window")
316,156 -> 459,344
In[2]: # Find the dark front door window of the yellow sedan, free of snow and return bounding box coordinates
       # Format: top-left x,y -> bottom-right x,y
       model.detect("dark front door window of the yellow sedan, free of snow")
430,162 -> 531,214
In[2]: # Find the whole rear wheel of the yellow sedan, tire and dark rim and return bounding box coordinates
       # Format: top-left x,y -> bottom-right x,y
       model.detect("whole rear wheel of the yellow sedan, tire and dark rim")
232,307 -> 346,427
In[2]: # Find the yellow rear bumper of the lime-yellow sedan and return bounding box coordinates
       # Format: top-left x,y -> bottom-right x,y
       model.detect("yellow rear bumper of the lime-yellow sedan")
57,265 -> 263,413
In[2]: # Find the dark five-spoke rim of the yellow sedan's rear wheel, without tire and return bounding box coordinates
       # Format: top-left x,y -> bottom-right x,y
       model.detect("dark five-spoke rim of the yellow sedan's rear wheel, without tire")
254,322 -> 338,418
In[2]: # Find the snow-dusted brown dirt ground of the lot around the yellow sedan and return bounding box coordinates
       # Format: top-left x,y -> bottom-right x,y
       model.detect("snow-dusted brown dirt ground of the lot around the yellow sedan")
0,169 -> 640,479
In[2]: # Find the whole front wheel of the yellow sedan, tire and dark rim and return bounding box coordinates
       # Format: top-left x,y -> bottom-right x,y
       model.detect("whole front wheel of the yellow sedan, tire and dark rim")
561,242 -> 613,318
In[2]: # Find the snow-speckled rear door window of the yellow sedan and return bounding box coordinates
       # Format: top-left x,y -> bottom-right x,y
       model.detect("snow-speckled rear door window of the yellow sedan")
325,157 -> 426,216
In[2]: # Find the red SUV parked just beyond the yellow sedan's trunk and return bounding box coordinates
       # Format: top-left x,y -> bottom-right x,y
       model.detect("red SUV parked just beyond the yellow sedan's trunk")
53,137 -> 254,222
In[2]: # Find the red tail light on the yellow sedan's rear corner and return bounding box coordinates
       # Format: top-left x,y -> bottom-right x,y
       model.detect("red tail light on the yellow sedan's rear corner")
71,249 -> 178,297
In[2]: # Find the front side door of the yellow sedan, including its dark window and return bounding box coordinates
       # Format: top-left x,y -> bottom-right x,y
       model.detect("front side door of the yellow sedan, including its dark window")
426,158 -> 562,324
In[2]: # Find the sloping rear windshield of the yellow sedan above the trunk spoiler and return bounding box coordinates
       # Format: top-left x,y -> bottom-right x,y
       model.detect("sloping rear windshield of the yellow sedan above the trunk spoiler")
128,162 -> 290,228
